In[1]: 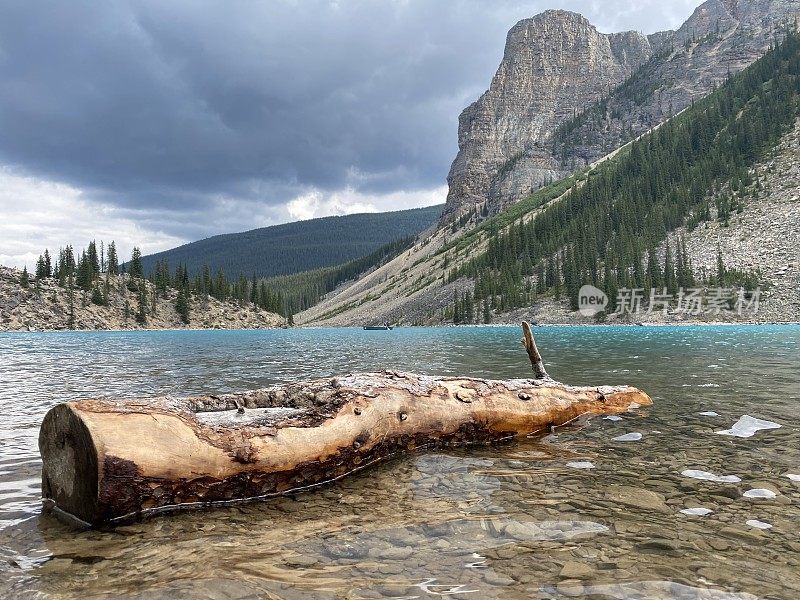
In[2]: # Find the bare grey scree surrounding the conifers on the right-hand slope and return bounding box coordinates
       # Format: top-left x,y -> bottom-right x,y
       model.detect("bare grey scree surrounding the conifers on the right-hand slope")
296,121 -> 800,326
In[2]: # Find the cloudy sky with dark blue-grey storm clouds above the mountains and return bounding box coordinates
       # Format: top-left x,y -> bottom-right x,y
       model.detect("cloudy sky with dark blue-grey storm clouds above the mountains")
0,0 -> 700,267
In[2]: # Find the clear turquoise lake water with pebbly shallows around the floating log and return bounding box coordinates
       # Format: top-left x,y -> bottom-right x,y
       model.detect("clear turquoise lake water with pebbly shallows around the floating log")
0,326 -> 800,600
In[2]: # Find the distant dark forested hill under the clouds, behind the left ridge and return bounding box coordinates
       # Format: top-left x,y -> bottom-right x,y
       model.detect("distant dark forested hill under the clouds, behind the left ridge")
136,206 -> 442,277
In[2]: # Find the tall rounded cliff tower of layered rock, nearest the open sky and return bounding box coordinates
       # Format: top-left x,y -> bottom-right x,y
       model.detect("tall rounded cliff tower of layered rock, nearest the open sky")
446,10 -> 651,214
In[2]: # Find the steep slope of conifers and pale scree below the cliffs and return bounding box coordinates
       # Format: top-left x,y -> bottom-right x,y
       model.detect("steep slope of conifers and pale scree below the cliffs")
296,34 -> 800,325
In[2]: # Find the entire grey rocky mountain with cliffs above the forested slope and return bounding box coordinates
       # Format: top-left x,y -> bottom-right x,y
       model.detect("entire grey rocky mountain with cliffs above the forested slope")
443,0 -> 800,221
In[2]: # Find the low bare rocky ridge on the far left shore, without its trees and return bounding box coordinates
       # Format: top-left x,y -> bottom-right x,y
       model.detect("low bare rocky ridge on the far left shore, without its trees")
0,267 -> 286,331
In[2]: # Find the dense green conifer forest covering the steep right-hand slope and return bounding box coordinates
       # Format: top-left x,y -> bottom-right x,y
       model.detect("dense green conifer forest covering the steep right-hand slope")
443,33 -> 800,323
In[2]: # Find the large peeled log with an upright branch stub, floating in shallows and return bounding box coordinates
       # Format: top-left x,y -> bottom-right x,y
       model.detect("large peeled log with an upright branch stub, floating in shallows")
39,323 -> 651,526
